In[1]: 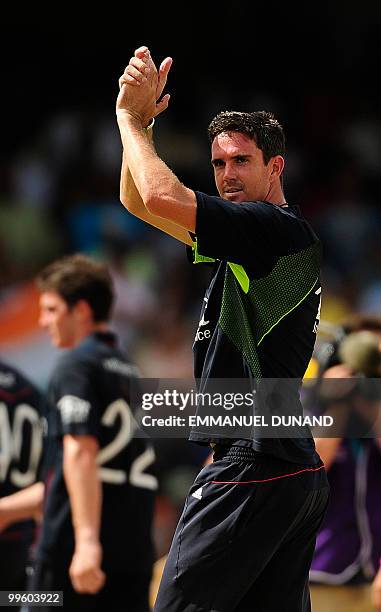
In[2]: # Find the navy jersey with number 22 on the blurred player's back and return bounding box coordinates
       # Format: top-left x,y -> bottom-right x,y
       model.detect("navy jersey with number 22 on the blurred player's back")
37,333 -> 157,571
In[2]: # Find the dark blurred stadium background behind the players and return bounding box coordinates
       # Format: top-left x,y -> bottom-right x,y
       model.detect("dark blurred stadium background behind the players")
0,7 -> 381,564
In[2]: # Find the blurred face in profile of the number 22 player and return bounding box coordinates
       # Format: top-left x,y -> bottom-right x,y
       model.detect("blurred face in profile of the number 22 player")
39,291 -> 78,348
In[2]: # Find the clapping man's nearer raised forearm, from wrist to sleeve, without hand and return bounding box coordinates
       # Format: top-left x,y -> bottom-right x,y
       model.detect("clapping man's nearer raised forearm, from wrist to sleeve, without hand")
118,113 -> 196,231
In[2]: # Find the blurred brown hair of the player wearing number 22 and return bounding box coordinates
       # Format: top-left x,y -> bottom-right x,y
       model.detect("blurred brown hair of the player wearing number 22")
37,254 -> 114,323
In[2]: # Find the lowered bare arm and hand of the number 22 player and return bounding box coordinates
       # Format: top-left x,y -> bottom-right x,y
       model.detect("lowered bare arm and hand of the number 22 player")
63,434 -> 106,593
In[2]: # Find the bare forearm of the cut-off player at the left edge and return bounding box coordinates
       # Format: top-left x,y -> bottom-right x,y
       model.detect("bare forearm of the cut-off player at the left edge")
0,482 -> 44,532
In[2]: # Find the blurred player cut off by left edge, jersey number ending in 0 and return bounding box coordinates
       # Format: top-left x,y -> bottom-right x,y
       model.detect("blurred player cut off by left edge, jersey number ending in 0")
0,361 -> 44,609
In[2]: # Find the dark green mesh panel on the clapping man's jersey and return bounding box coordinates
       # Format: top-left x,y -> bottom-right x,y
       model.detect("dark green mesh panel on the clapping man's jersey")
219,243 -> 320,378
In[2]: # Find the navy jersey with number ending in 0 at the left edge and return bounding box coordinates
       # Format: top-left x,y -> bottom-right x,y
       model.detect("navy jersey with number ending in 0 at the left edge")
0,362 -> 44,540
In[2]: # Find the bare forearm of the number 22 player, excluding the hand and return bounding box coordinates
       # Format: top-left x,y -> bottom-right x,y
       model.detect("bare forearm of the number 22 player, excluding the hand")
63,436 -> 102,546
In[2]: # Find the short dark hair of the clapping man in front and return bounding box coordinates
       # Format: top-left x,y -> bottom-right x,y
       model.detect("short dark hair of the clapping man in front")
208,111 -> 286,165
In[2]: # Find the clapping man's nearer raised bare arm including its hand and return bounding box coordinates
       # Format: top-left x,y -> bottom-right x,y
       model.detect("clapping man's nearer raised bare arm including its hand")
116,50 -> 196,233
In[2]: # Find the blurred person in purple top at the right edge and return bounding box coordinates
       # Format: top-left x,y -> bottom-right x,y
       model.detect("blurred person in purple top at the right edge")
310,316 -> 381,612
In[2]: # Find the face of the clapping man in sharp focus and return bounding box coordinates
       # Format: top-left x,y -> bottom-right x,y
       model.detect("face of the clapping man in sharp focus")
212,132 -> 272,204
